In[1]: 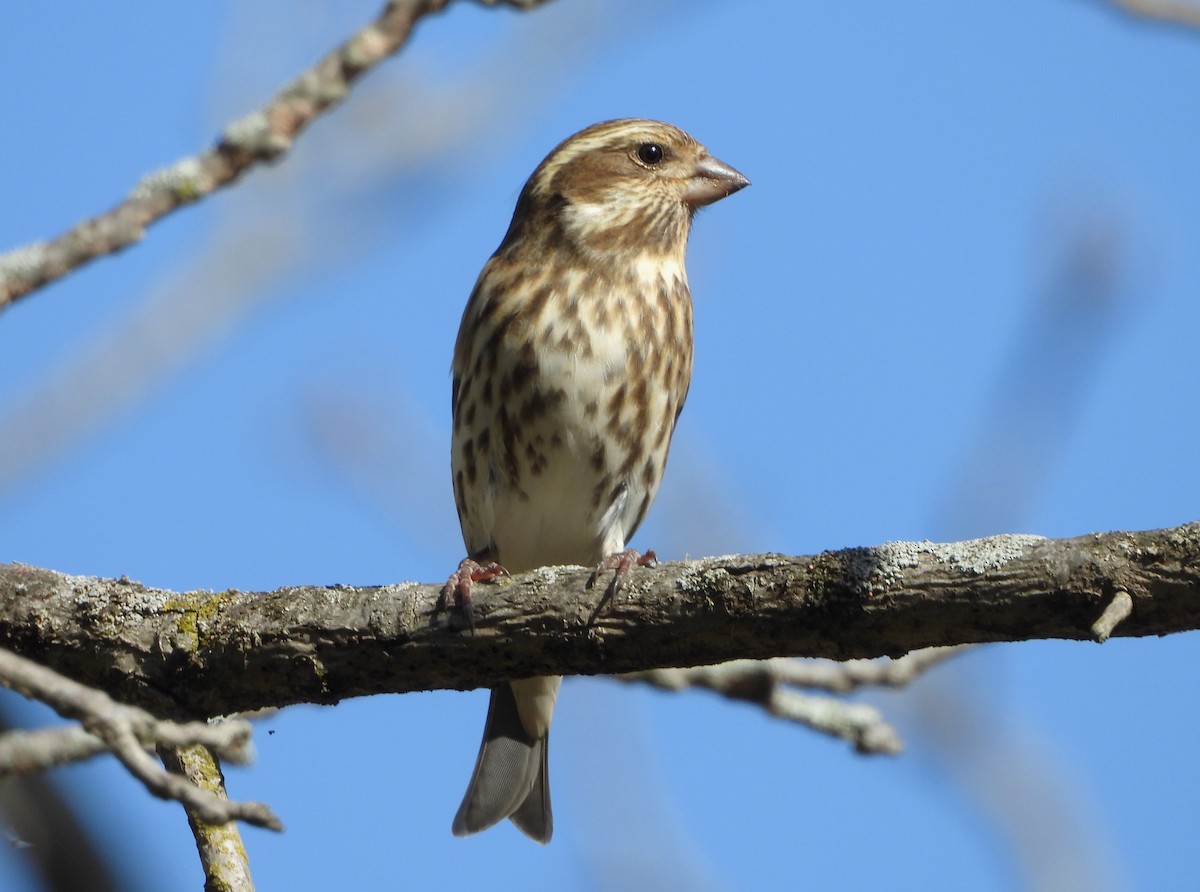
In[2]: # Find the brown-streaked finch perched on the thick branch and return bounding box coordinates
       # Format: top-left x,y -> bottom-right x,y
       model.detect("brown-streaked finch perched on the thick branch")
443,119 -> 749,843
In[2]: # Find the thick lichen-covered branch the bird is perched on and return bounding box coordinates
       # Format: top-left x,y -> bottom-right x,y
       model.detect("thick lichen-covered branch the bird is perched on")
0,523 -> 1200,720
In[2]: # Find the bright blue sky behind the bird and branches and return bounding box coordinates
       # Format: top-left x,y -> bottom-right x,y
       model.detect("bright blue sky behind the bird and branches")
0,0 -> 1200,892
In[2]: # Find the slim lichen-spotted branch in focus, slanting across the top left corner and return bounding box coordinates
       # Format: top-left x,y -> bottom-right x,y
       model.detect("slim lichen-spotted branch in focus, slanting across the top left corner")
0,0 -> 545,311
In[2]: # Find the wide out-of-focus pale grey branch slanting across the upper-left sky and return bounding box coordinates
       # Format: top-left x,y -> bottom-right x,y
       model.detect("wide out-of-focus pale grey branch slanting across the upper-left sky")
0,2 -> 604,494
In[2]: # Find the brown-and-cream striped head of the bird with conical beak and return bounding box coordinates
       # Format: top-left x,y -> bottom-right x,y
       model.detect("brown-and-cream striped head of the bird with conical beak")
502,118 -> 750,259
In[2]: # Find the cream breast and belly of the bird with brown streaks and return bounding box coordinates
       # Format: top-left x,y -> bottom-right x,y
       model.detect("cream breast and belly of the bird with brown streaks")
452,250 -> 691,571
